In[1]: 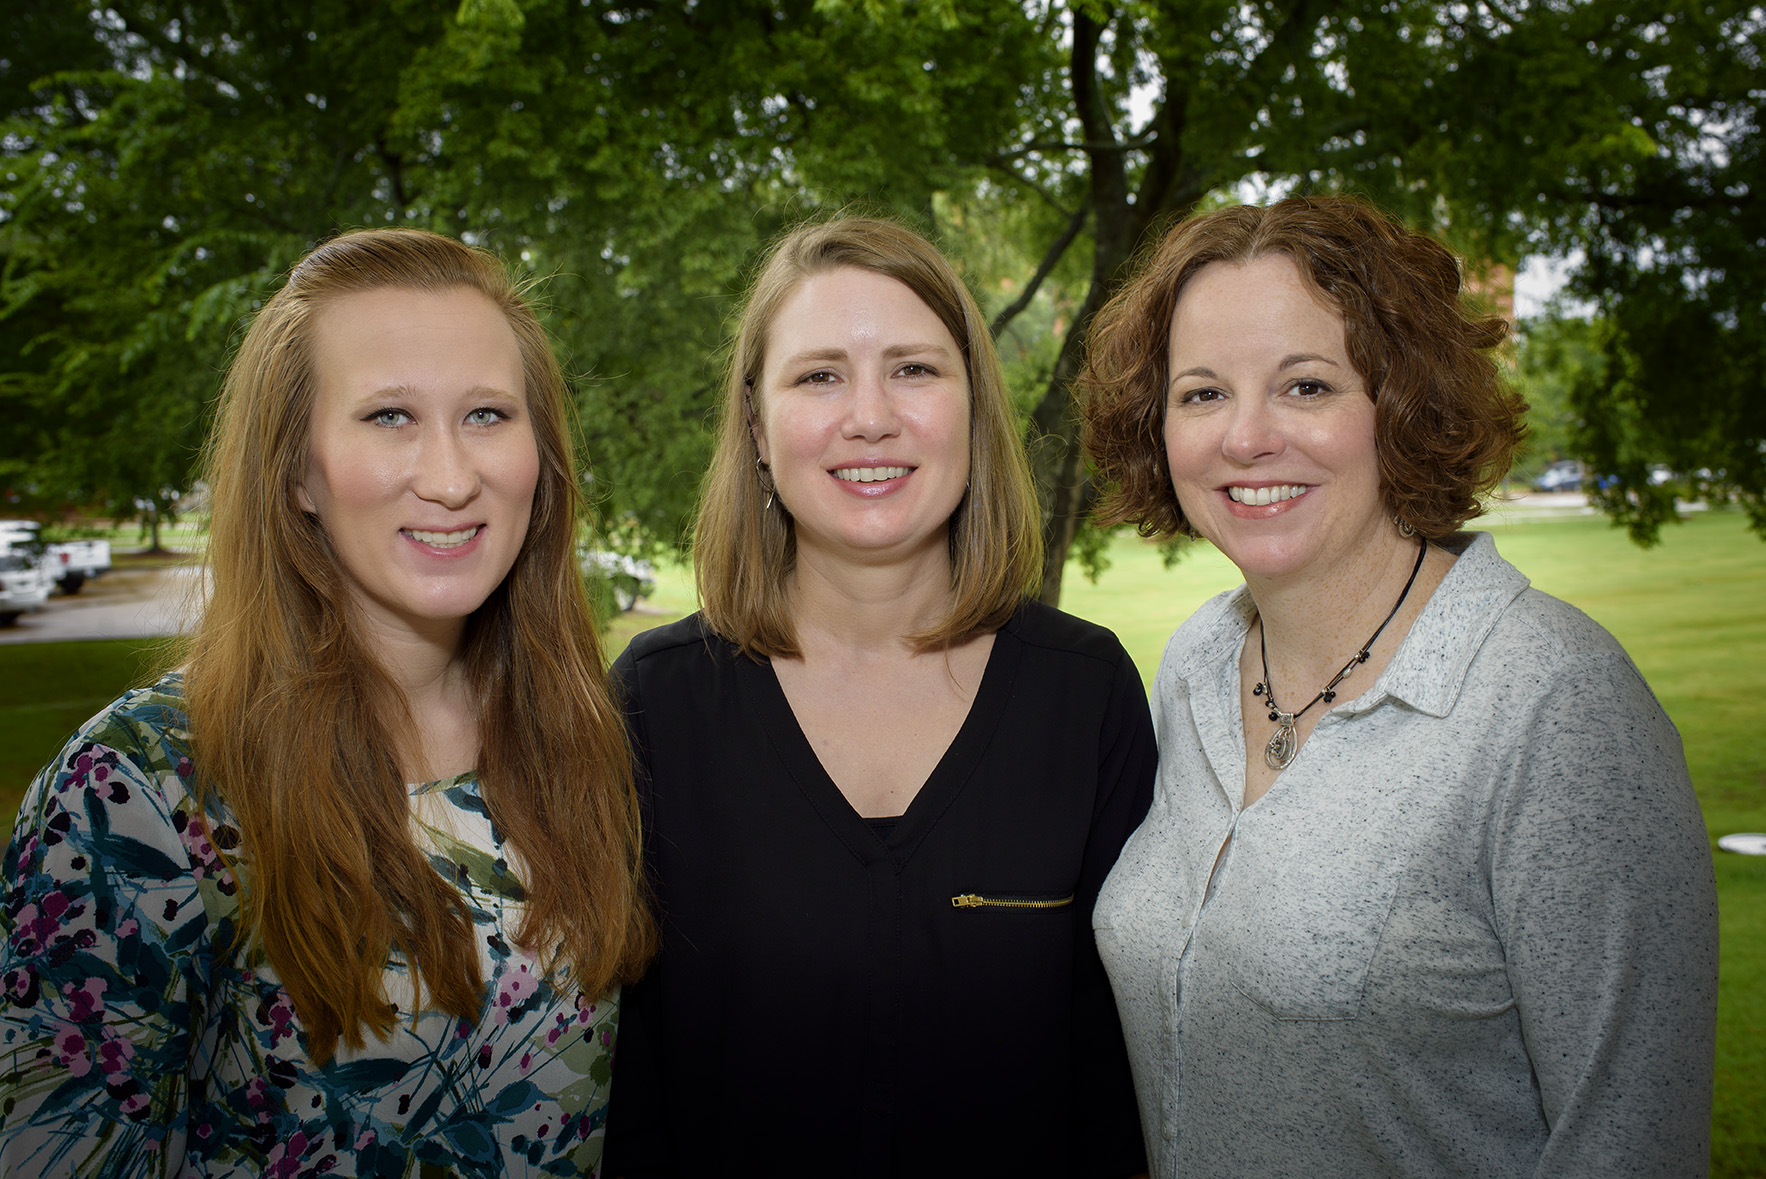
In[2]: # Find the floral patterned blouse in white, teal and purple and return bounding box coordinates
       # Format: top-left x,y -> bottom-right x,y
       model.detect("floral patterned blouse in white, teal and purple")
0,674 -> 618,1179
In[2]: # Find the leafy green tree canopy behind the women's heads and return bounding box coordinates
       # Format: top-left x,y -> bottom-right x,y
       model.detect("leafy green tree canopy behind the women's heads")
0,0 -> 1766,600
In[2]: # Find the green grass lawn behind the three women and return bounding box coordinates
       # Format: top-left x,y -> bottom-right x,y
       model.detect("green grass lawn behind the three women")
0,512 -> 1766,1179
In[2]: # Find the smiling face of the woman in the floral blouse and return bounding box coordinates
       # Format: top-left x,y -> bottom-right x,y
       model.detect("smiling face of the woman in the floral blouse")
295,288 -> 539,653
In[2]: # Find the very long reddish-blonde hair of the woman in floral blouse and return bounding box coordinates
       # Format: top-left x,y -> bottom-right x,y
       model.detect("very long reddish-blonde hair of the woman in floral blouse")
184,229 -> 655,1061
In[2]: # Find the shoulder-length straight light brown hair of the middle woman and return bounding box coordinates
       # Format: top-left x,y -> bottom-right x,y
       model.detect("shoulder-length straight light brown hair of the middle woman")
692,217 -> 1042,657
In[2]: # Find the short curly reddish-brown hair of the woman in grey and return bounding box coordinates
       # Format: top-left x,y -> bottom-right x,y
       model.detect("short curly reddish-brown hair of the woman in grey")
1079,196 -> 1526,538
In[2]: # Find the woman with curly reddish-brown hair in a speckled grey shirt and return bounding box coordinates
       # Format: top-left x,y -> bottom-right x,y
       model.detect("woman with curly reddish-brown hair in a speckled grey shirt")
1084,198 -> 1717,1179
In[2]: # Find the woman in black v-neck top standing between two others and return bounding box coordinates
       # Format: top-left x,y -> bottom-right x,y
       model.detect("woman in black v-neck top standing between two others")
606,219 -> 1157,1179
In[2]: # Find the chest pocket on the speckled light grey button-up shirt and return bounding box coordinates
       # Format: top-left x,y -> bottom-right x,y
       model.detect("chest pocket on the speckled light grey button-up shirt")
1215,800 -> 1406,1020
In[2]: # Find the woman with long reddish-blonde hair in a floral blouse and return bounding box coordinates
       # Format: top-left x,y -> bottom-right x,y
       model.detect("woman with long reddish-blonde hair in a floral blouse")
0,229 -> 653,1175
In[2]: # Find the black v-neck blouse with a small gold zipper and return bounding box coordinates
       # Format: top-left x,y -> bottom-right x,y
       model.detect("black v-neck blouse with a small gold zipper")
602,604 -> 1158,1179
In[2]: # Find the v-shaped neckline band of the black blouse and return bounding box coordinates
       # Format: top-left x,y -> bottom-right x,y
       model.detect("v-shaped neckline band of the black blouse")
743,614 -> 1024,863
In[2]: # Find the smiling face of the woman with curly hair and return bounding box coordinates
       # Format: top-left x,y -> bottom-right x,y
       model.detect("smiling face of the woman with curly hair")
1166,254 -> 1393,579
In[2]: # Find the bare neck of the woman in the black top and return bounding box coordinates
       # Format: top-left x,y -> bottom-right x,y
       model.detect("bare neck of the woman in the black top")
789,535 -> 952,658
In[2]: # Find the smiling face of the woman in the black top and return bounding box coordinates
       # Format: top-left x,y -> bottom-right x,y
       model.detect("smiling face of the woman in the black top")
754,267 -> 970,578
